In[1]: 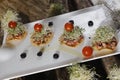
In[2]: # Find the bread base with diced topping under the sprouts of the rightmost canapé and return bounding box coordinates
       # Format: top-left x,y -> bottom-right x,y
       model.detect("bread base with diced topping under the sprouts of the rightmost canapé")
92,37 -> 118,56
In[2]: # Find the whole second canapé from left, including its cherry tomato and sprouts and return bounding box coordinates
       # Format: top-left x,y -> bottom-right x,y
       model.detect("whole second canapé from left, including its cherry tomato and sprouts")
31,24 -> 53,45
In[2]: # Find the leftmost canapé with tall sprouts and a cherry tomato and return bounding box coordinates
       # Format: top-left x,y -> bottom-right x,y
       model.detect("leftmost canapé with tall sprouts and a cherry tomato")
1,10 -> 25,41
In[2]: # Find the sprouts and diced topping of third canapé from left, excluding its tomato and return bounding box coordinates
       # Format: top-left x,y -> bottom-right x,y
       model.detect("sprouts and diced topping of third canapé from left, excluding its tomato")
61,26 -> 84,47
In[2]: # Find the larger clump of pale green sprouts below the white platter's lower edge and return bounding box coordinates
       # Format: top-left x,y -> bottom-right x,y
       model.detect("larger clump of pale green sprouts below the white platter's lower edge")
67,64 -> 97,80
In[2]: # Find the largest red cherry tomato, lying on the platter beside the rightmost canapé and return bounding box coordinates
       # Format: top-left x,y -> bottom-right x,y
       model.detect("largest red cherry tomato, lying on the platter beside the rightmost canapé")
82,46 -> 93,58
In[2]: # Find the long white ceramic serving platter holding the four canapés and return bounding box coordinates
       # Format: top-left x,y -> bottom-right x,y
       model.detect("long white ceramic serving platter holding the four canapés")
0,5 -> 120,80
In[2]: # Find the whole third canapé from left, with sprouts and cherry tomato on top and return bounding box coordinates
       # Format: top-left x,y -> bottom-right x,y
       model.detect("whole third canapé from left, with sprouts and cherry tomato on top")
60,21 -> 84,47
